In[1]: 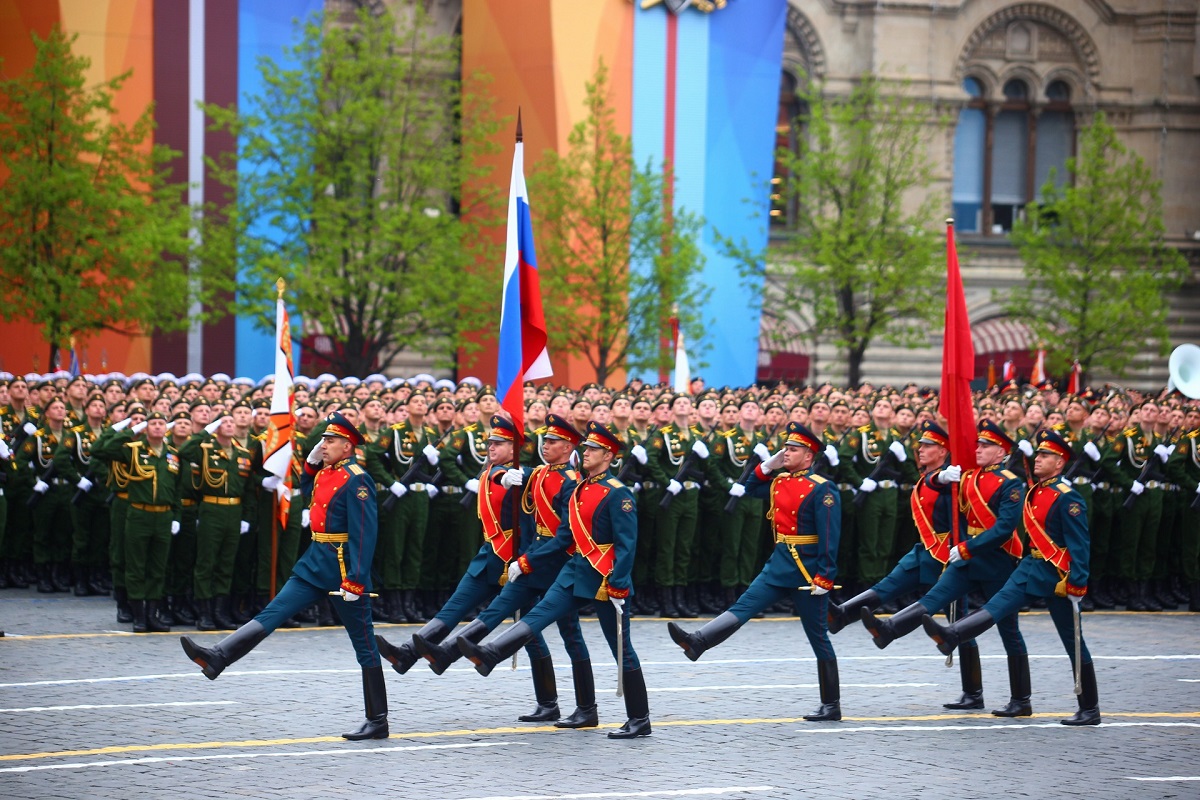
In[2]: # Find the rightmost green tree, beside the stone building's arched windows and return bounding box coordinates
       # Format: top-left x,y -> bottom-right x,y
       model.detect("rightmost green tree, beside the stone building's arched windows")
1007,114 -> 1188,379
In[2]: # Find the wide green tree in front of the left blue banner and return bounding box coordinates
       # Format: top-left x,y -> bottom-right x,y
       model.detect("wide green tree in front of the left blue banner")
204,4 -> 500,374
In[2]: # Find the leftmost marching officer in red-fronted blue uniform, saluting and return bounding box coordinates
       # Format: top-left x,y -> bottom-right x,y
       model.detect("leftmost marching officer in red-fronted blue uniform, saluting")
180,411 -> 388,740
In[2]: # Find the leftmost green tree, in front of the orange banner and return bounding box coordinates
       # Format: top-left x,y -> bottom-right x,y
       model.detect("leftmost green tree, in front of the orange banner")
0,28 -> 190,365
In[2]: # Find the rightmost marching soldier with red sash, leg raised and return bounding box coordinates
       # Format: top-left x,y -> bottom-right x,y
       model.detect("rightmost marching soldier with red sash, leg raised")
922,431 -> 1100,726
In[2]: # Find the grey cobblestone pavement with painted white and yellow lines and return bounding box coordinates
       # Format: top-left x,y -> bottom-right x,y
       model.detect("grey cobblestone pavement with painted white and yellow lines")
0,590 -> 1200,800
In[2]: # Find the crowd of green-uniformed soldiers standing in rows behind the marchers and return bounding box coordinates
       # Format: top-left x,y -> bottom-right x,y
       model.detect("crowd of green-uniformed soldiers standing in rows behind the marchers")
0,372 -> 1200,631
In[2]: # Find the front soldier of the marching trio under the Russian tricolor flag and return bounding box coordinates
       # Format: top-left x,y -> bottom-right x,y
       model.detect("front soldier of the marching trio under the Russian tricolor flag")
458,422 -> 650,739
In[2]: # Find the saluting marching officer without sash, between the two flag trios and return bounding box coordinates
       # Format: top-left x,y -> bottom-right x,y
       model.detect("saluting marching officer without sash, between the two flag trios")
667,422 -> 841,722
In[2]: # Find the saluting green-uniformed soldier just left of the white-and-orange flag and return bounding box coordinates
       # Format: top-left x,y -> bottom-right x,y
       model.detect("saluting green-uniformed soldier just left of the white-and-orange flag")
181,431 -> 256,630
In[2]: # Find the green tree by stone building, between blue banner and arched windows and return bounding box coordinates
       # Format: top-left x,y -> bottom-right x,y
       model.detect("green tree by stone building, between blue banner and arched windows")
725,74 -> 944,385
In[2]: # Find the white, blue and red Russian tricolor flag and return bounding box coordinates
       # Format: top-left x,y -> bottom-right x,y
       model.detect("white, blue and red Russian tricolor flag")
496,112 -> 554,432
